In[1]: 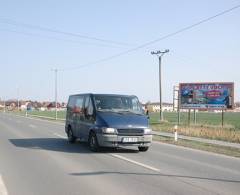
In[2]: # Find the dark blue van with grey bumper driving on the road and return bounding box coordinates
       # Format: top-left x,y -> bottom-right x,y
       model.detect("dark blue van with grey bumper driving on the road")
65,94 -> 152,151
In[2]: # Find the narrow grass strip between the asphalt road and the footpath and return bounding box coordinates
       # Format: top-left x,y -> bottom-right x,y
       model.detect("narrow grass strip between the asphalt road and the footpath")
153,136 -> 240,158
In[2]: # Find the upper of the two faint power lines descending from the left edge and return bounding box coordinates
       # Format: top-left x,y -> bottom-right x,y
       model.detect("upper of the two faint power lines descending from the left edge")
0,18 -> 130,46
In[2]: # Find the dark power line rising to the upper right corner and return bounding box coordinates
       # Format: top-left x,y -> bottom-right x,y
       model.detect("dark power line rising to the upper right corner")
61,4 -> 240,71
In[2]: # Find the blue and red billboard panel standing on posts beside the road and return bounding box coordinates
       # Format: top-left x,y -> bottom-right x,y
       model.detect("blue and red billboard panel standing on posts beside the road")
179,82 -> 234,109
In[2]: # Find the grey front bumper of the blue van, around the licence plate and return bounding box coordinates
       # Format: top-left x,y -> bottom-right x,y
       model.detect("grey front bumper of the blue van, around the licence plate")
97,134 -> 152,147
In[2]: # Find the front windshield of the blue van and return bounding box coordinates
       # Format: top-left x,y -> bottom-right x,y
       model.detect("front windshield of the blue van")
94,95 -> 143,114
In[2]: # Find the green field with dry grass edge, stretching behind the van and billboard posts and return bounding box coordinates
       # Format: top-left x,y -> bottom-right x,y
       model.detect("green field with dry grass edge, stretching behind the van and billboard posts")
8,111 -> 240,143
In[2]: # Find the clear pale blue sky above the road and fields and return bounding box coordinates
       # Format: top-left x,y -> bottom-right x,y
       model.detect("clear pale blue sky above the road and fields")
0,0 -> 240,102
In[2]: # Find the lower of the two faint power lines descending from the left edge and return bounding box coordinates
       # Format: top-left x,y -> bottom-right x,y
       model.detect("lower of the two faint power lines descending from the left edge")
0,29 -> 124,48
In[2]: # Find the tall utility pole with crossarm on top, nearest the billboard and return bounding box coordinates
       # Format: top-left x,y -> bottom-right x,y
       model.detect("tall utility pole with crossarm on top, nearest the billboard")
151,49 -> 169,121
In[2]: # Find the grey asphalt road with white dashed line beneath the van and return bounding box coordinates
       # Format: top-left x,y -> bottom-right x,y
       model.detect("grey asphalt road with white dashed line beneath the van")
0,113 -> 240,195
